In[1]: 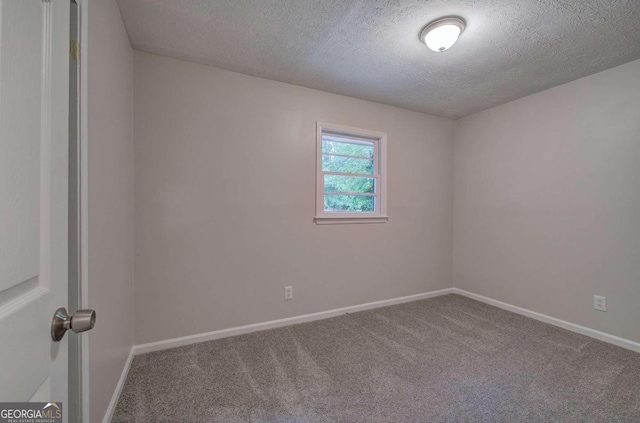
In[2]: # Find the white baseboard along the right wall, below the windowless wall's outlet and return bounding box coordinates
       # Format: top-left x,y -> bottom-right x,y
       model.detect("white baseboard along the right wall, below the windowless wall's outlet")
451,288 -> 640,352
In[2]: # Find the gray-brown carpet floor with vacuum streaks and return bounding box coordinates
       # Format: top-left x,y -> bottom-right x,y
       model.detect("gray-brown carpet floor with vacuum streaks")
113,295 -> 640,423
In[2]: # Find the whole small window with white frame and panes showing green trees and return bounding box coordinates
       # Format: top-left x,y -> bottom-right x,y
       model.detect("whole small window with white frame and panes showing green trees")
315,122 -> 388,224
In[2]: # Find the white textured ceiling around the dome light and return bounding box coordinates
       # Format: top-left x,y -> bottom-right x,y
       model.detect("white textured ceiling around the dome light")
118,0 -> 640,118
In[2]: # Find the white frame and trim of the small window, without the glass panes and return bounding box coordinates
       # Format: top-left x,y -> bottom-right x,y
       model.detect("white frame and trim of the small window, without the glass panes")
314,122 -> 389,225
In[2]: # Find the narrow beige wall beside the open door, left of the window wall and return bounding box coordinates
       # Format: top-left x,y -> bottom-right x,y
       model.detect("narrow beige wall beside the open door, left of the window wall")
83,0 -> 134,422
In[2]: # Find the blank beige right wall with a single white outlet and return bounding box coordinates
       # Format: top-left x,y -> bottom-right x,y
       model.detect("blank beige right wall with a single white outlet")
454,61 -> 640,341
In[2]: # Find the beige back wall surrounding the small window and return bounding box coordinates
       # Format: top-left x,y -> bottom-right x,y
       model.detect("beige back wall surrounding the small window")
135,51 -> 453,344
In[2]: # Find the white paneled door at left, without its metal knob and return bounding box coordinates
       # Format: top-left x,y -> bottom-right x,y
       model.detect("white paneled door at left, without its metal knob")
0,0 -> 70,415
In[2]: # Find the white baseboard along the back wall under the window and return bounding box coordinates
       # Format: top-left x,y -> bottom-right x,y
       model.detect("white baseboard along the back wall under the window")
133,288 -> 453,355
